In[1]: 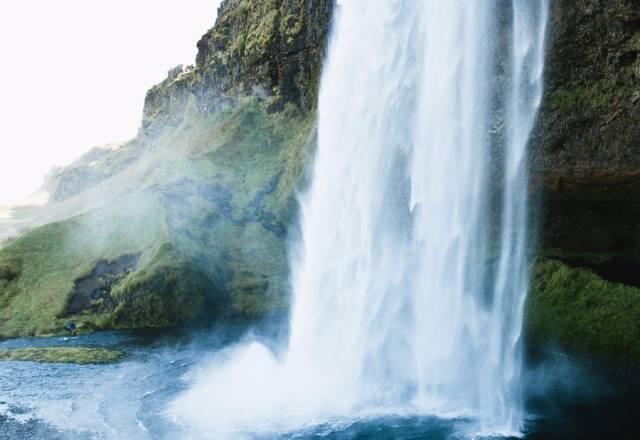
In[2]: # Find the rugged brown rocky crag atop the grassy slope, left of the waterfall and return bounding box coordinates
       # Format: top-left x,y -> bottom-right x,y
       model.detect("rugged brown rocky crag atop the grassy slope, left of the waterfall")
142,0 -> 334,134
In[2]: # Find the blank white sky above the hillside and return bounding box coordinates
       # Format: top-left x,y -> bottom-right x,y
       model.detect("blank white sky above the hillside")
0,0 -> 220,205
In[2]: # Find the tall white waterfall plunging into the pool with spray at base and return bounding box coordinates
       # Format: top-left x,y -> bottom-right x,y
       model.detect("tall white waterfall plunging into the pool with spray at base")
171,0 -> 547,433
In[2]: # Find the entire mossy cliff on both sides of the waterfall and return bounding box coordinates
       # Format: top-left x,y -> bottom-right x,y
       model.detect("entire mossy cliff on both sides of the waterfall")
0,0 -> 640,364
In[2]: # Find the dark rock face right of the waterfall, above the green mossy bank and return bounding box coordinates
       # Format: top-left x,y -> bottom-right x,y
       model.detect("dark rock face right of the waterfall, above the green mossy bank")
532,0 -> 640,260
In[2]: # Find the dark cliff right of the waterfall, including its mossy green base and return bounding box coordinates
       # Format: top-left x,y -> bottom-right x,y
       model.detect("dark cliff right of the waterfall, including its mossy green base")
529,0 -> 640,364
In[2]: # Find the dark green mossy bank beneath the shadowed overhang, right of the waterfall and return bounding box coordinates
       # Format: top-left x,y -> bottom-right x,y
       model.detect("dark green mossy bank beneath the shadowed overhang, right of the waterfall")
527,259 -> 640,365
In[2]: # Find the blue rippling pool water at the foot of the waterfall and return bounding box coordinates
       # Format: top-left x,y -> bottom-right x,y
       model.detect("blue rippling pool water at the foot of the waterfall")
0,327 -> 640,440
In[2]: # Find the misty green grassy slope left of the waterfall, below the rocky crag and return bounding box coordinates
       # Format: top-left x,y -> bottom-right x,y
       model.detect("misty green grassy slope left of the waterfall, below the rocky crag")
0,99 -> 314,337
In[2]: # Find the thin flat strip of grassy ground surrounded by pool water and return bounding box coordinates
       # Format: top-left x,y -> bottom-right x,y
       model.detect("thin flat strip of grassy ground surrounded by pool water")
0,347 -> 125,365
